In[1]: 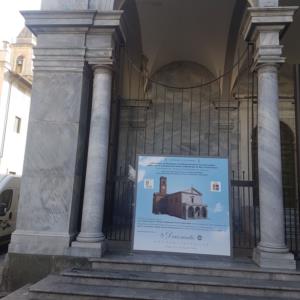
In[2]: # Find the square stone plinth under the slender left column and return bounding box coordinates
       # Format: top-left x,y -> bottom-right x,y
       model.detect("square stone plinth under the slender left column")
68,240 -> 107,258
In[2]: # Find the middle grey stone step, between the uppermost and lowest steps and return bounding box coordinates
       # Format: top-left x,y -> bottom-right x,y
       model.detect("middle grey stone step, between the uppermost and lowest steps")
58,269 -> 300,299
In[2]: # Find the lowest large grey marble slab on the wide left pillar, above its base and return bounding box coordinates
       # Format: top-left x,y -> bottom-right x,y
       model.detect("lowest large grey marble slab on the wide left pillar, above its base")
17,171 -> 78,234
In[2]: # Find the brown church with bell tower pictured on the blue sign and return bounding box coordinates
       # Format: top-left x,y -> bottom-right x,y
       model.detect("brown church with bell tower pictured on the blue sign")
153,177 -> 208,220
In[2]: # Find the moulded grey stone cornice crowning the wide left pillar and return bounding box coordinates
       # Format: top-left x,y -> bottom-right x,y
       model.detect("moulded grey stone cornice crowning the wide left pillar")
22,10 -> 125,72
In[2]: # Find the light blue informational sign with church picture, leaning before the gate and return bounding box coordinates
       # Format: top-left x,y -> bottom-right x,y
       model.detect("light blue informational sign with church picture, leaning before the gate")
133,156 -> 231,256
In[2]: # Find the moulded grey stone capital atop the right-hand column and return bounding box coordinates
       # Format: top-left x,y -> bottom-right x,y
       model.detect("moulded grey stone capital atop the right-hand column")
243,6 -> 298,70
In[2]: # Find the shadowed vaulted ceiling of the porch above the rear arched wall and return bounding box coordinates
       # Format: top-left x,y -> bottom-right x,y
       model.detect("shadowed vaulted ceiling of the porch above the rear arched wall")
136,0 -> 237,75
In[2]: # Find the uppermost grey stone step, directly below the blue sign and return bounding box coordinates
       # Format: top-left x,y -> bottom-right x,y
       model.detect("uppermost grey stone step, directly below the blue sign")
90,254 -> 300,285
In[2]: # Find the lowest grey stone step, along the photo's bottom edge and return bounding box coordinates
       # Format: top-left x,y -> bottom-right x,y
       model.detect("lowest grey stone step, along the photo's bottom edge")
24,275 -> 288,300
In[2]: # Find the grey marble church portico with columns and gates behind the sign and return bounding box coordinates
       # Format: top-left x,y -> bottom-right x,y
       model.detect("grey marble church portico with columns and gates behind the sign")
4,0 -> 300,284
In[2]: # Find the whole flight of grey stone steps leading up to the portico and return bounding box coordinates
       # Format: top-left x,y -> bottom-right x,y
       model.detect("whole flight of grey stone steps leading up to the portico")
4,254 -> 300,300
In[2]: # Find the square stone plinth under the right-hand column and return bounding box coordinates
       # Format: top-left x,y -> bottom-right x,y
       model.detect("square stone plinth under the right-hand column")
253,248 -> 296,270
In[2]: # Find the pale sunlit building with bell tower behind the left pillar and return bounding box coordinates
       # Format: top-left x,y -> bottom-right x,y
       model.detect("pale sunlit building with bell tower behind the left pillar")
0,28 -> 35,175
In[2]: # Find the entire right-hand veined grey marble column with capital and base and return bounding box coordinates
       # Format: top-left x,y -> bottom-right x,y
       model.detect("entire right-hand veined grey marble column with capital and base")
244,1 -> 297,269
